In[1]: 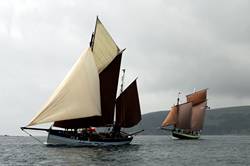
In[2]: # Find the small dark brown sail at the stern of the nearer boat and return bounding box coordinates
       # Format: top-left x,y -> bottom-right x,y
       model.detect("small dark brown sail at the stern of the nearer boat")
116,80 -> 141,128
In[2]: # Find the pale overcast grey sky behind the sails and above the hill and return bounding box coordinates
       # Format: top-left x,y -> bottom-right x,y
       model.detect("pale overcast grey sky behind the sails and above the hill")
0,0 -> 250,135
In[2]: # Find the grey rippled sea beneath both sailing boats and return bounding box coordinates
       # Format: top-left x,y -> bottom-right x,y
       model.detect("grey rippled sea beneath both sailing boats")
0,135 -> 250,166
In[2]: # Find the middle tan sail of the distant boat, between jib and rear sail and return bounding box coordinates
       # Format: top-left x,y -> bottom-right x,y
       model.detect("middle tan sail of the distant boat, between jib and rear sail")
176,103 -> 192,129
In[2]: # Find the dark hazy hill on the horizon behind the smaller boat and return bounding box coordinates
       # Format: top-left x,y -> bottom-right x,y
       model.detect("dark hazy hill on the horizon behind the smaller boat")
130,106 -> 250,135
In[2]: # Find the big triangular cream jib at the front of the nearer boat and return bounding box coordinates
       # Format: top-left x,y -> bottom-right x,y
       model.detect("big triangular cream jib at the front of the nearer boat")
28,48 -> 101,126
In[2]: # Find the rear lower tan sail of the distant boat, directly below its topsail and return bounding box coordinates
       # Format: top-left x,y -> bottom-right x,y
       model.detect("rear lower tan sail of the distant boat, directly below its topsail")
191,101 -> 207,131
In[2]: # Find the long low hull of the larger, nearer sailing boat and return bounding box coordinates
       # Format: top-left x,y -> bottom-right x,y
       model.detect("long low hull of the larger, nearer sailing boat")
46,133 -> 133,146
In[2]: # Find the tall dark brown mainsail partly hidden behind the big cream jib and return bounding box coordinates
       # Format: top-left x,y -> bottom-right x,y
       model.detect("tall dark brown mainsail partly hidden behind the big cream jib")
54,53 -> 122,128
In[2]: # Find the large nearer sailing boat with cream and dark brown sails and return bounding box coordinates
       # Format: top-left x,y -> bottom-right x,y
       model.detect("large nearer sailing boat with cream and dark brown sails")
21,17 -> 141,146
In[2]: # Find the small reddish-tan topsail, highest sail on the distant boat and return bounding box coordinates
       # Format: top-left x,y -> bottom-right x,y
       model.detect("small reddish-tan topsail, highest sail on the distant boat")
186,89 -> 207,105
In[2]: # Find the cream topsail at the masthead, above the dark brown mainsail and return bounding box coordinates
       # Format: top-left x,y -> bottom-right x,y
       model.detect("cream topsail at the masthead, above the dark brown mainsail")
92,18 -> 119,73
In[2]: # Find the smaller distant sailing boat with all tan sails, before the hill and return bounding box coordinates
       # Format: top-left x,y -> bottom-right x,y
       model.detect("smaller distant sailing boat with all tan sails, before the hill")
162,89 -> 207,139
